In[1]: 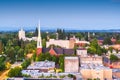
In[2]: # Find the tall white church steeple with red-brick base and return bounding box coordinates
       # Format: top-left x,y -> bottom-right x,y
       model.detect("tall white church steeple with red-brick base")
37,20 -> 42,55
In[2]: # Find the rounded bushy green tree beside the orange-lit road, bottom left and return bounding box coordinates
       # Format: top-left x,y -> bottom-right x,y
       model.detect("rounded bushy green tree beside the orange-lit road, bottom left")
8,67 -> 22,77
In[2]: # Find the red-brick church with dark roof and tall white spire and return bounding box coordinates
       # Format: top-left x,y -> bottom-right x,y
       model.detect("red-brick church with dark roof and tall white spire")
36,21 -> 74,56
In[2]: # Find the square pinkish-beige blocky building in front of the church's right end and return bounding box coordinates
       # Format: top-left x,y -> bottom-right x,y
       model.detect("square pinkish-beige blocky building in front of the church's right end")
64,57 -> 79,72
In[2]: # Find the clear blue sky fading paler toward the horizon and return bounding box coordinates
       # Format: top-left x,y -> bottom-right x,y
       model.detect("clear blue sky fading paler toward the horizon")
0,0 -> 120,30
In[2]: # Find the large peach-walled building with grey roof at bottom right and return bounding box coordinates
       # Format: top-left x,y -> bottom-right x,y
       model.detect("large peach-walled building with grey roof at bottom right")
80,63 -> 112,80
